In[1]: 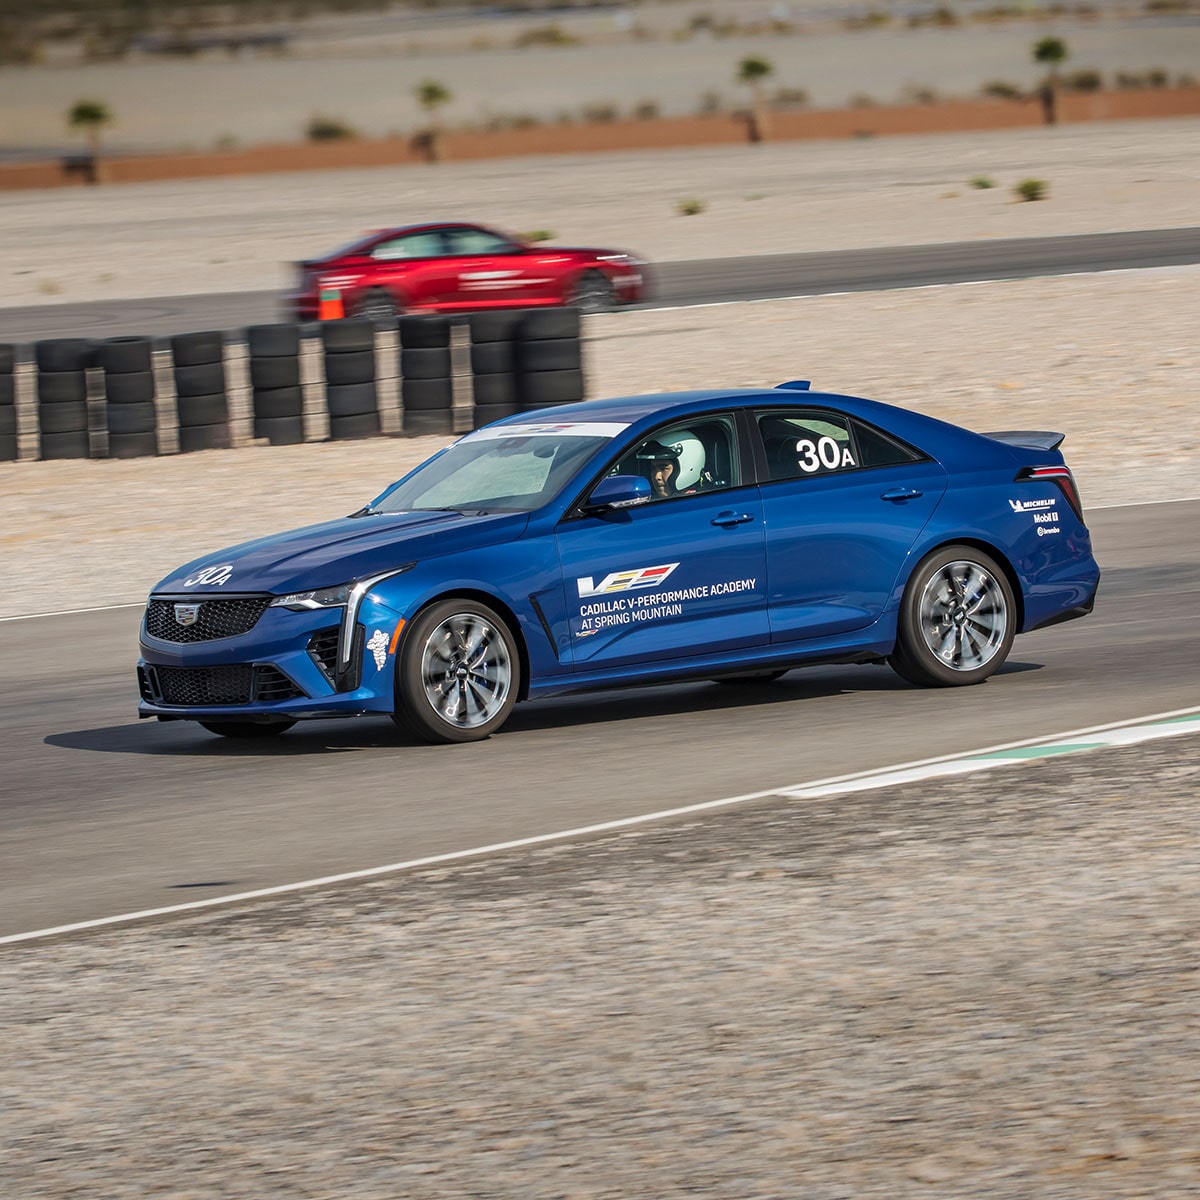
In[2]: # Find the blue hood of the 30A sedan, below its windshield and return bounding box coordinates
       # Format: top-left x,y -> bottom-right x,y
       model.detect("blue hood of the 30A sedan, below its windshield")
154,512 -> 529,595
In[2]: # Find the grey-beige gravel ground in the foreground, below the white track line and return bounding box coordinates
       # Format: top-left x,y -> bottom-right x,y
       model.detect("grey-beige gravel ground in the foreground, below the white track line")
0,738 -> 1200,1200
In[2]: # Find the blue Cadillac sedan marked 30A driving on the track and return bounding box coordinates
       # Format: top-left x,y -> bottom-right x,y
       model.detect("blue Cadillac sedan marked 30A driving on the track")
138,380 -> 1099,743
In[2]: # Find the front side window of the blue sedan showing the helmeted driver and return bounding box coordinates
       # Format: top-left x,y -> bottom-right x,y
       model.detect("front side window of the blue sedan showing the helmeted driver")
612,416 -> 740,502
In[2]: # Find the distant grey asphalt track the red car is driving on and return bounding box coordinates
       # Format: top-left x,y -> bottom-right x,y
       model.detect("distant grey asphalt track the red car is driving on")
0,228 -> 1200,343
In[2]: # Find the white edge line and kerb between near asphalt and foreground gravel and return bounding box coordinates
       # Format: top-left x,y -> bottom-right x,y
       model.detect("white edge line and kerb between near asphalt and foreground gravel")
0,707 -> 1200,946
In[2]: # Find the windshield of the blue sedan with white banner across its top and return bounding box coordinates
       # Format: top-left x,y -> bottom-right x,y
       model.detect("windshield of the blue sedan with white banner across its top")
370,422 -> 623,512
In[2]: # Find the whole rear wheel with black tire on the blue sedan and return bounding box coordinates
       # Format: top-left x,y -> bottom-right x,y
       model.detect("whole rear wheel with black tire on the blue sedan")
888,546 -> 1018,688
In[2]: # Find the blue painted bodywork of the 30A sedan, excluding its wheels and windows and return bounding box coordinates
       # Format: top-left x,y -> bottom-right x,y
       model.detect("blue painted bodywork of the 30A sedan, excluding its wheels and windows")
138,386 -> 1099,721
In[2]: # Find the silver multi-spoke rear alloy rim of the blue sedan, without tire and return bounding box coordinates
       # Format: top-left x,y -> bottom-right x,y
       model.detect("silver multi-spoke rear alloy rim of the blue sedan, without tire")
919,559 -> 1008,671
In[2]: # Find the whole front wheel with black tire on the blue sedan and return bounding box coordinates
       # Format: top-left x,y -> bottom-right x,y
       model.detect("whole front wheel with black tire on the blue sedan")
394,599 -> 521,744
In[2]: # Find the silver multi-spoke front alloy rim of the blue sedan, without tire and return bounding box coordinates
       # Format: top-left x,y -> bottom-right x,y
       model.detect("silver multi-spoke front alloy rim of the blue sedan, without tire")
421,612 -> 512,730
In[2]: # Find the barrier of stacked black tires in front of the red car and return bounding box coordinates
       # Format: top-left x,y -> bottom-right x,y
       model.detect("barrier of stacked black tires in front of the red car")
0,308 -> 586,461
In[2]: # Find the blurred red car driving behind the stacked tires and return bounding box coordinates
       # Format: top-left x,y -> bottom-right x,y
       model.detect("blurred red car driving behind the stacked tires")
289,223 -> 644,320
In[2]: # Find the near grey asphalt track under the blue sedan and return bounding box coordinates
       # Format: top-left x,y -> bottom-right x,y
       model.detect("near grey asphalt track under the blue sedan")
0,500 -> 1200,935
